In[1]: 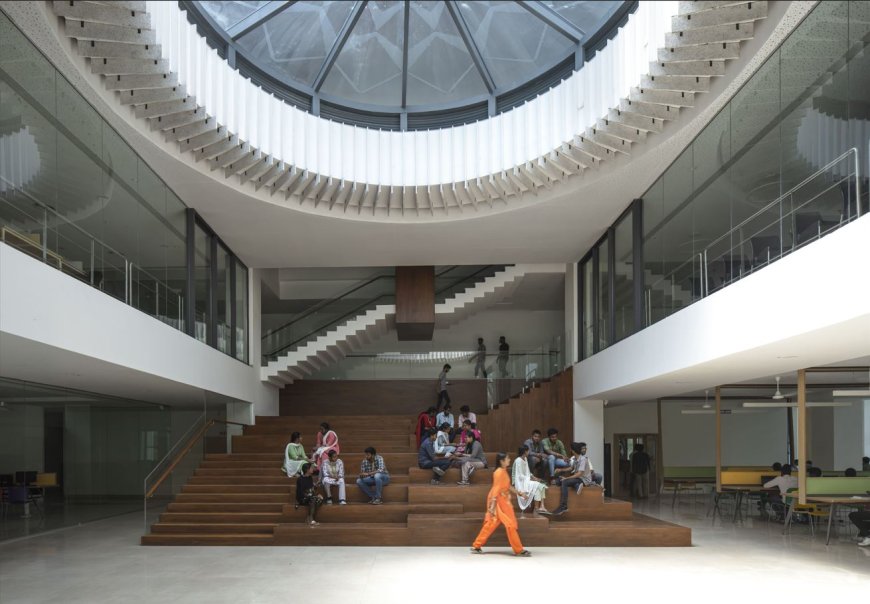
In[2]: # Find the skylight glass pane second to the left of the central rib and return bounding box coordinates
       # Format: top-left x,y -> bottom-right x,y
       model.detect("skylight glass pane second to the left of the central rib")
238,1 -> 356,86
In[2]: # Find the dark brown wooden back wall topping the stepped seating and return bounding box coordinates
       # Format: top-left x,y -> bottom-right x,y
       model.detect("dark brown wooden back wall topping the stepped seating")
279,377 -> 487,417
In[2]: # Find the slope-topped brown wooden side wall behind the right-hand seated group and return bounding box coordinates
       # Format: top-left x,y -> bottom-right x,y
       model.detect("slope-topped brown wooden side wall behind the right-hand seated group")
478,368 -> 574,455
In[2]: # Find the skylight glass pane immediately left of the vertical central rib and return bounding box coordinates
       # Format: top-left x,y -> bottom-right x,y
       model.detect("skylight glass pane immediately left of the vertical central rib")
321,1 -> 405,107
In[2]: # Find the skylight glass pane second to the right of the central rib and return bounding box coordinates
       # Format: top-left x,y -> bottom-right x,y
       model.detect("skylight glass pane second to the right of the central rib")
458,0 -> 576,89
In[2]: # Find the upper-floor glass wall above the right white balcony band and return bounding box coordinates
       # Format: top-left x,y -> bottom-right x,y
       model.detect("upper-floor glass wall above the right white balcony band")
577,2 -> 870,358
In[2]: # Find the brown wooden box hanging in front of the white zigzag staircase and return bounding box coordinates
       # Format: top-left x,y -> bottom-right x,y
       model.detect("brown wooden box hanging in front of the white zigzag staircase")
396,266 -> 435,341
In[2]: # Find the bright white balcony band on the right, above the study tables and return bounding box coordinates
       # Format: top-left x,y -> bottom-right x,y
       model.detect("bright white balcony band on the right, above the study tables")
574,216 -> 870,400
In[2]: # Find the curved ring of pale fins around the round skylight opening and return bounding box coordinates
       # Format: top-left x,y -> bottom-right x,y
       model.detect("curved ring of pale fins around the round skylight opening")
53,2 -> 767,221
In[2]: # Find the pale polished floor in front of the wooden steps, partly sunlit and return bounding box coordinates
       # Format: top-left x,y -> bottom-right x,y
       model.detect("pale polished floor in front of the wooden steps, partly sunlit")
0,497 -> 870,604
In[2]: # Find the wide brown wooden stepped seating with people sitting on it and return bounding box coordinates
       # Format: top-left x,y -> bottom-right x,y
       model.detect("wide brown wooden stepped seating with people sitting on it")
142,415 -> 691,547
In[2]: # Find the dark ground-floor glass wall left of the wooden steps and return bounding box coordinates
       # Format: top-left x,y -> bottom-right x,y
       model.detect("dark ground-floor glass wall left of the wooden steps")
0,379 -> 208,540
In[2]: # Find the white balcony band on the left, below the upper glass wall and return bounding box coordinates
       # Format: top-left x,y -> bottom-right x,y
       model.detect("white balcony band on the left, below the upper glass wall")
0,245 -> 277,414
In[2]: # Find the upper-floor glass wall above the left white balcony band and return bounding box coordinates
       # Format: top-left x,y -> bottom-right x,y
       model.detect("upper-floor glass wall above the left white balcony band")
0,13 -> 248,362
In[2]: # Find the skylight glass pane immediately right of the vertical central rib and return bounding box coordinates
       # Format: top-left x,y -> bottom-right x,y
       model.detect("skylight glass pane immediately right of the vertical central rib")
407,1 -> 487,106
